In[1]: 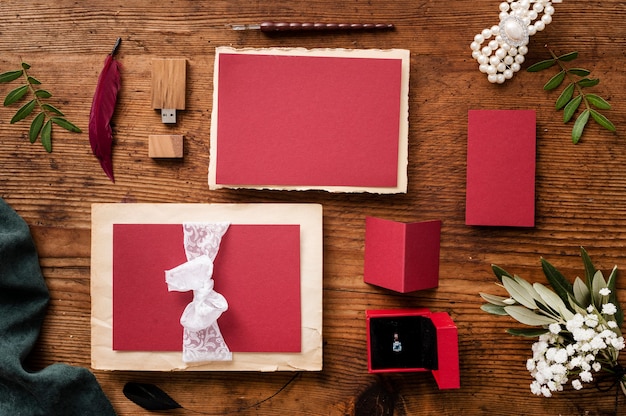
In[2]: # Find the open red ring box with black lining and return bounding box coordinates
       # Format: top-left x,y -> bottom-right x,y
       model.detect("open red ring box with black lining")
365,308 -> 460,389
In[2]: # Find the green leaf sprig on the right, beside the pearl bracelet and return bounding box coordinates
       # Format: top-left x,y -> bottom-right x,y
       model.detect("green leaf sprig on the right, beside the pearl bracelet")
527,49 -> 615,144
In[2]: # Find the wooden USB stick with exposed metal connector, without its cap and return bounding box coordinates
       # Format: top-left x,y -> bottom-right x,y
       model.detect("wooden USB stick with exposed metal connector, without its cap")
152,58 -> 187,124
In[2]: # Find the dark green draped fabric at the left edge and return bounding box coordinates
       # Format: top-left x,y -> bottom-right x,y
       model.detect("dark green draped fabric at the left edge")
0,198 -> 115,416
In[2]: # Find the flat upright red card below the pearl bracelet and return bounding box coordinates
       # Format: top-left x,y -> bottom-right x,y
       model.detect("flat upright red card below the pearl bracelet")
465,110 -> 536,227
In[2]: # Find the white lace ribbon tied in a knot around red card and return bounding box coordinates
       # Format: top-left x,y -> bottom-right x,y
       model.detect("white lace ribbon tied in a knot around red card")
165,223 -> 232,362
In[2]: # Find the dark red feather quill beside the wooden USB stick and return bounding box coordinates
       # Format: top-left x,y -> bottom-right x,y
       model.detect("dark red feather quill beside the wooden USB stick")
89,39 -> 122,182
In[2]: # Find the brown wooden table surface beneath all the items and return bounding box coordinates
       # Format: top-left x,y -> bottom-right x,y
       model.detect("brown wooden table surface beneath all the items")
0,0 -> 626,415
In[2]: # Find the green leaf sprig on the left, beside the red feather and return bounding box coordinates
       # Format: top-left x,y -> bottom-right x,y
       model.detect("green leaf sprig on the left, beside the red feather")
0,62 -> 81,152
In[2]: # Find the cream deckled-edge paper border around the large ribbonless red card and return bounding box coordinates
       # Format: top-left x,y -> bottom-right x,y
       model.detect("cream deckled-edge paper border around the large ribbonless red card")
208,46 -> 410,194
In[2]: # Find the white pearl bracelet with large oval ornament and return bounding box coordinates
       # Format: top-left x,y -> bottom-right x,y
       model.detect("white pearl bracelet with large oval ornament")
470,0 -> 562,84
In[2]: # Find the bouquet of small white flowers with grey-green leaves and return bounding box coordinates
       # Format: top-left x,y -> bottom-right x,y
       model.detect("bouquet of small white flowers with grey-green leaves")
480,249 -> 626,397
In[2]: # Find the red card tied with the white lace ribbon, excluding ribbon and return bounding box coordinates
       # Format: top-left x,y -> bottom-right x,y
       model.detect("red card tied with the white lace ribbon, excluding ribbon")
113,224 -> 301,352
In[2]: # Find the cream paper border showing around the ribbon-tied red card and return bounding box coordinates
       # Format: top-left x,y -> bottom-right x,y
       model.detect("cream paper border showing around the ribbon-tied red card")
91,204 -> 323,371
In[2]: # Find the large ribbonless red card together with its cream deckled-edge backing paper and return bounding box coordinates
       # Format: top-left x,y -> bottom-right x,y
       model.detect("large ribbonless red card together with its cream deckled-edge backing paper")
209,47 -> 409,193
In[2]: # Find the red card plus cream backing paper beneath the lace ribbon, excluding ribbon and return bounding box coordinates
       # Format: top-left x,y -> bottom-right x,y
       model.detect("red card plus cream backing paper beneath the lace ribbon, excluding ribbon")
92,204 -> 322,371
